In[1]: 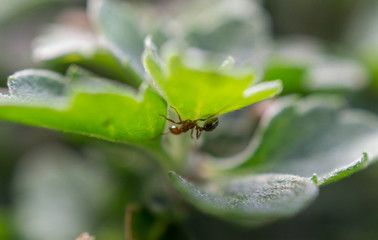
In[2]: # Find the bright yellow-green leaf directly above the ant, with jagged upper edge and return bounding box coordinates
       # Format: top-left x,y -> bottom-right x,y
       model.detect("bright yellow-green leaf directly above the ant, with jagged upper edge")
143,39 -> 282,119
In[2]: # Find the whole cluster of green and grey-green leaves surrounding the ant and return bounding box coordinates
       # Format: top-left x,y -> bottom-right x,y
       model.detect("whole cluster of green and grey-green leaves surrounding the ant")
0,0 -> 378,239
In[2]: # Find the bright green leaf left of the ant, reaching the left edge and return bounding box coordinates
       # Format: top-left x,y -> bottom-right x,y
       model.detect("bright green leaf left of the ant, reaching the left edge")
0,67 -> 167,146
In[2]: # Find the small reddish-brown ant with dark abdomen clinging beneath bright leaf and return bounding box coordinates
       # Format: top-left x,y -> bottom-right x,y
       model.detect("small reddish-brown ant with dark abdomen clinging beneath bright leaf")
160,106 -> 219,140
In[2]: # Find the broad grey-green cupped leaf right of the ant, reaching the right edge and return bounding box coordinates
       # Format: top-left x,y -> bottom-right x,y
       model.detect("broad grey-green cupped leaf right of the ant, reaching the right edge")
213,96 -> 378,184
